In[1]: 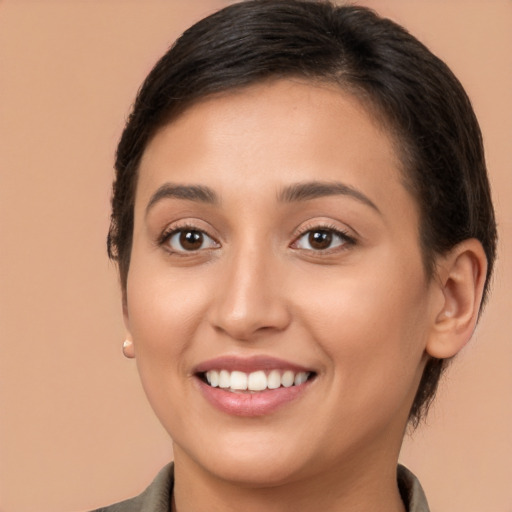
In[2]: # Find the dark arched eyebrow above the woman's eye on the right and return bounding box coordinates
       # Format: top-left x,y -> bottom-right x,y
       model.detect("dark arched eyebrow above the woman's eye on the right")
278,181 -> 381,213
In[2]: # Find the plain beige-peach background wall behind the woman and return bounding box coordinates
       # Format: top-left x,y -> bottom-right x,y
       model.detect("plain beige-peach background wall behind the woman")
0,0 -> 512,512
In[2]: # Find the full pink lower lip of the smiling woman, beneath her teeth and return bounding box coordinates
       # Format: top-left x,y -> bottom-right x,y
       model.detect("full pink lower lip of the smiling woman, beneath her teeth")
197,378 -> 310,416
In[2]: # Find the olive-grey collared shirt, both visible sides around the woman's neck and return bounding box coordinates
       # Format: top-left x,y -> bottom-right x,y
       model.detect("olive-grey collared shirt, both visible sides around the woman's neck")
92,463 -> 429,512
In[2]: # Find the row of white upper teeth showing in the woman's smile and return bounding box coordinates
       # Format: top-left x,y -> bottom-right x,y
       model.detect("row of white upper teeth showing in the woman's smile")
205,370 -> 310,391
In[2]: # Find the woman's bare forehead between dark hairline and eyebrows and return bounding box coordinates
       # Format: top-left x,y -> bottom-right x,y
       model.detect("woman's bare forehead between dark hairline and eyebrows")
137,79 -> 414,218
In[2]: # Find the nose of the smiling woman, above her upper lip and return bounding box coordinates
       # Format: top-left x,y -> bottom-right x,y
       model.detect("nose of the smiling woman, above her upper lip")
209,244 -> 291,341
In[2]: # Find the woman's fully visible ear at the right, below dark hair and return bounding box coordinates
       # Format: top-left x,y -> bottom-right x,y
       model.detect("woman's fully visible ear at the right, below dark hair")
426,238 -> 487,359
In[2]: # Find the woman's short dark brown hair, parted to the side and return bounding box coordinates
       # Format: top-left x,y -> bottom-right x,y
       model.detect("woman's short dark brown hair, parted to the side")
108,0 -> 497,425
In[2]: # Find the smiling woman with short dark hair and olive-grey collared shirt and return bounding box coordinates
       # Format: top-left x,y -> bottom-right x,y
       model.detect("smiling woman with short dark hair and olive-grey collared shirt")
95,0 -> 496,512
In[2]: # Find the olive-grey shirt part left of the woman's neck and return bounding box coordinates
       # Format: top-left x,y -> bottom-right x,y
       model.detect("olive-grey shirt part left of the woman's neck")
91,463 -> 174,512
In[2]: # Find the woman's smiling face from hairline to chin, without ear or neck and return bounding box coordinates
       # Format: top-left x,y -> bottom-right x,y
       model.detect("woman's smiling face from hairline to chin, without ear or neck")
125,80 -> 436,485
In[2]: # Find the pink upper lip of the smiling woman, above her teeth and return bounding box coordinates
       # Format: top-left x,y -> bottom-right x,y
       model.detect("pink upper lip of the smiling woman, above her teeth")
194,355 -> 313,373
